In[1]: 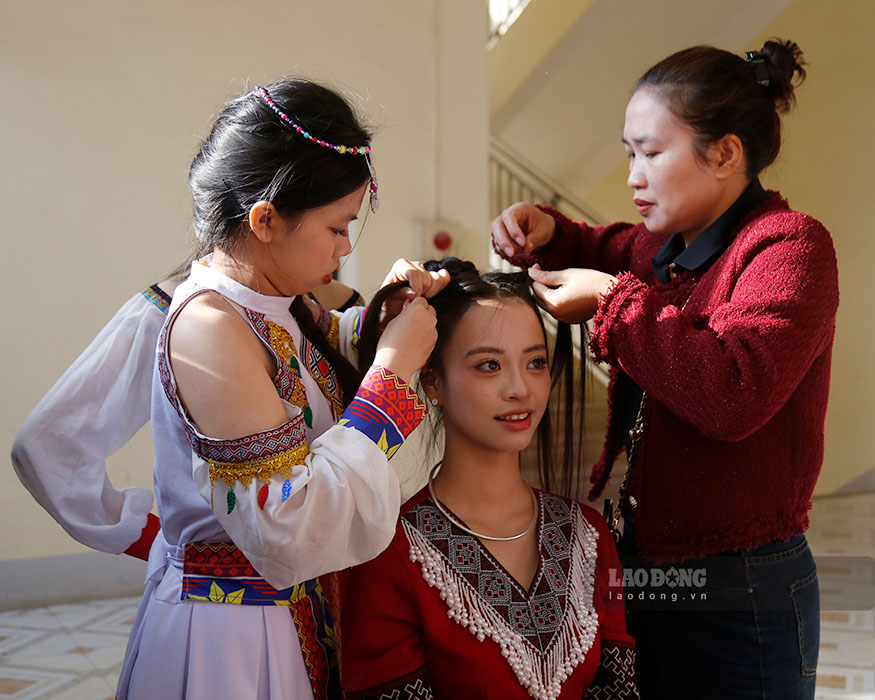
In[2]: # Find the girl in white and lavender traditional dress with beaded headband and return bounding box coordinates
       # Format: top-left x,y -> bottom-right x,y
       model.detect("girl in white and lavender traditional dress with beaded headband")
118,80 -> 445,700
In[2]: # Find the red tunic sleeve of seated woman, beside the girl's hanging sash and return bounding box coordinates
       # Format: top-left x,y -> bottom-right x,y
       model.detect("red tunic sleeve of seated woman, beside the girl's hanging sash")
341,528 -> 432,700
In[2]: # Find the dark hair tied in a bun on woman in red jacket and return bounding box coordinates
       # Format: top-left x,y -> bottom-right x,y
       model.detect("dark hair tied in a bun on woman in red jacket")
636,39 -> 806,178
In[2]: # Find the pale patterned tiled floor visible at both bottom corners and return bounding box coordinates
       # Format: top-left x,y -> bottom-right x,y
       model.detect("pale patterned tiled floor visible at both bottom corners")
0,494 -> 875,700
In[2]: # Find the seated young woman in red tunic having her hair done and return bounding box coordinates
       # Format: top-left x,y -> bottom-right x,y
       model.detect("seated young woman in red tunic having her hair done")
341,258 -> 638,700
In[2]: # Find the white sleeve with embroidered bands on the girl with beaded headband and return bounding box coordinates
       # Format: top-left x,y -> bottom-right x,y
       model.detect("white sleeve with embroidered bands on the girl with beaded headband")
186,367 -> 426,589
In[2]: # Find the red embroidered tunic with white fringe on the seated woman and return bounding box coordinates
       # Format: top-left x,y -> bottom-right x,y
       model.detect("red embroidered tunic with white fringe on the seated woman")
341,489 -> 637,700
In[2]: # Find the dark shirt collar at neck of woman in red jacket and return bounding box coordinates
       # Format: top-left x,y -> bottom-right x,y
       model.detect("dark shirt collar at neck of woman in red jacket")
650,178 -> 769,283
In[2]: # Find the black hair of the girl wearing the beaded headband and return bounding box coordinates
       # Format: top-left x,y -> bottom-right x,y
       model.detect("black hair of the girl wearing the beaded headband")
188,78 -> 371,404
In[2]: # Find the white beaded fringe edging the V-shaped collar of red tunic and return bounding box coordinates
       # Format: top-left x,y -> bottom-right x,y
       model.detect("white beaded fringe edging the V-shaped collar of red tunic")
401,512 -> 598,700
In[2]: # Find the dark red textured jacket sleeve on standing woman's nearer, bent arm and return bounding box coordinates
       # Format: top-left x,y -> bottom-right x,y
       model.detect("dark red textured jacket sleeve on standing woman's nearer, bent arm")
590,211 -> 838,441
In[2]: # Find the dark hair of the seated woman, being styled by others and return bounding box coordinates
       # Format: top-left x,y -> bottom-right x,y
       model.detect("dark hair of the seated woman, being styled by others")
358,257 -> 584,498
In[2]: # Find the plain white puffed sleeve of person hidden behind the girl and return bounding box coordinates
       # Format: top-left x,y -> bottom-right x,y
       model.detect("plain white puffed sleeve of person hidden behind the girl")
12,290 -> 167,554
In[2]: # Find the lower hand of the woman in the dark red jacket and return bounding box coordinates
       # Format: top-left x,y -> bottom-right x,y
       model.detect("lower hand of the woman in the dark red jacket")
529,265 -> 617,323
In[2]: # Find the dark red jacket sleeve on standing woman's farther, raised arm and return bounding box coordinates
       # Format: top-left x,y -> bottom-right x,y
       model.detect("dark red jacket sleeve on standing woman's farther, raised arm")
497,205 -> 640,274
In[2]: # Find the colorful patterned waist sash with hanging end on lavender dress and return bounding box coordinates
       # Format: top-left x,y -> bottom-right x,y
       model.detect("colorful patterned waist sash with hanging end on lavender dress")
182,542 -> 341,699
